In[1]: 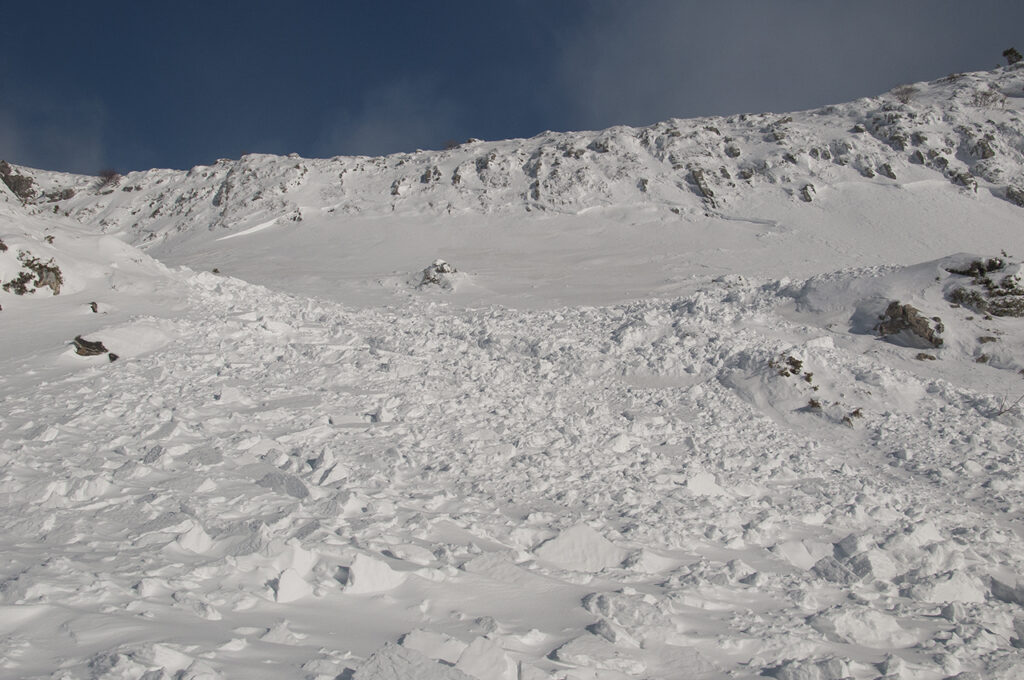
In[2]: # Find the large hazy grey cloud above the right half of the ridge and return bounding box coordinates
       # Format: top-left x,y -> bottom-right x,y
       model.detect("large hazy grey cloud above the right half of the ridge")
555,0 -> 1022,128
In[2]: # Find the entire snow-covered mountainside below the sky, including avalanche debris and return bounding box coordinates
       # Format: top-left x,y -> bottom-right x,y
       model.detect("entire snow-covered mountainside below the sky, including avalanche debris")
0,69 -> 1024,680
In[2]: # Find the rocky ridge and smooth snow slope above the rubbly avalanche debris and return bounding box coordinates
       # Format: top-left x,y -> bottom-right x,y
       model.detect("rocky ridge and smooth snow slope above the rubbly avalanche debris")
6,65 -> 1024,306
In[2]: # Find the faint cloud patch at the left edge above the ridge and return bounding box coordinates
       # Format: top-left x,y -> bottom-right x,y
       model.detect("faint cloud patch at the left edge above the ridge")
0,91 -> 108,174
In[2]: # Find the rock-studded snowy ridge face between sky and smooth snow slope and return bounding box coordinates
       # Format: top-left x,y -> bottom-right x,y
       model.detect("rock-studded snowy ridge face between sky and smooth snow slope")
11,67 -> 1024,251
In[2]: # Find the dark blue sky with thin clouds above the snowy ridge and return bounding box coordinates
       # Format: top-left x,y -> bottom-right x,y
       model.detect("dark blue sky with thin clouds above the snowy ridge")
6,0 -> 1024,174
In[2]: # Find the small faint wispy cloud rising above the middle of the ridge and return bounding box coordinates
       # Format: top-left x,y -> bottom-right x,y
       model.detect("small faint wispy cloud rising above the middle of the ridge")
317,78 -> 461,156
